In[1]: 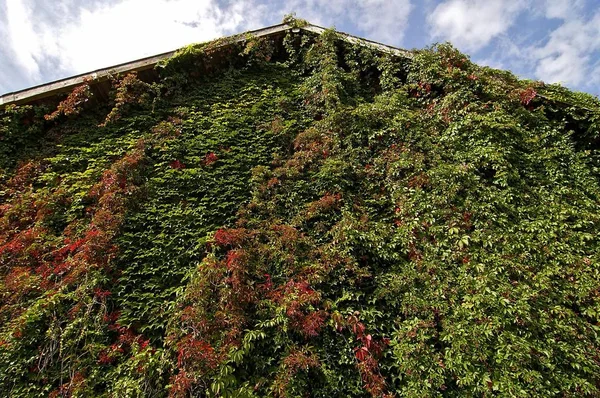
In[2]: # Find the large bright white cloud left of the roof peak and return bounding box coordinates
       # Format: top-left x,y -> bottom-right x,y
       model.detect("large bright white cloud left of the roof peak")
0,0 -> 265,91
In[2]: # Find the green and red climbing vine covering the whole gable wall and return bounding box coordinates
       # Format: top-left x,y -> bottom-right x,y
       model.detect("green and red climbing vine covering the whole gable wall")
0,21 -> 600,397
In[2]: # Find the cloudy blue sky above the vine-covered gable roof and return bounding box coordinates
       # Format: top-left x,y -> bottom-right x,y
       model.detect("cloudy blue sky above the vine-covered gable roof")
0,0 -> 600,95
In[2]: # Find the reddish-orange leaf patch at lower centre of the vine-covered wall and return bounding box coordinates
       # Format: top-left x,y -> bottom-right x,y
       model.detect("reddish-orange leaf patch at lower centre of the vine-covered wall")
172,216 -> 338,394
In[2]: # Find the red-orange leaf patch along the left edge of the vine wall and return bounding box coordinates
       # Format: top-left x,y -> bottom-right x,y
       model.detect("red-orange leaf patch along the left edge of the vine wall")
0,121 -> 173,396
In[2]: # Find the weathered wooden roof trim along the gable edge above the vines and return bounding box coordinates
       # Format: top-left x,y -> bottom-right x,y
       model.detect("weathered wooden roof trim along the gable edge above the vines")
0,23 -> 410,106
